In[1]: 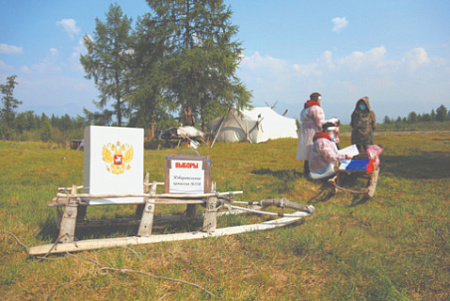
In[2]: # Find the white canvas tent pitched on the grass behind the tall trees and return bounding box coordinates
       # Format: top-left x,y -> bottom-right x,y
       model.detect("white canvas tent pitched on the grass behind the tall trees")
210,107 -> 298,143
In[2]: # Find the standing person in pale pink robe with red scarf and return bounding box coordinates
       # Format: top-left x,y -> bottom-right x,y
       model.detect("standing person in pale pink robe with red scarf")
296,92 -> 325,176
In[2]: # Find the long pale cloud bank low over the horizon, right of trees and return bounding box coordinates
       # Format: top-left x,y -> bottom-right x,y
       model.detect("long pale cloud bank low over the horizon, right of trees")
238,45 -> 450,123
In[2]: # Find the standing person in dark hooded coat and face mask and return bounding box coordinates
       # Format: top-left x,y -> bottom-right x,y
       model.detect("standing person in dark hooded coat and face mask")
350,96 -> 376,153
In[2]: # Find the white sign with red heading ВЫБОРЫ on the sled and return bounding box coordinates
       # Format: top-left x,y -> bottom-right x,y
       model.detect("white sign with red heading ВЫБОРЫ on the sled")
169,159 -> 205,194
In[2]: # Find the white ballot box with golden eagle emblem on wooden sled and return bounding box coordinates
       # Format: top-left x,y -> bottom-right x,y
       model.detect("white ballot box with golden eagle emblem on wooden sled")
83,126 -> 144,205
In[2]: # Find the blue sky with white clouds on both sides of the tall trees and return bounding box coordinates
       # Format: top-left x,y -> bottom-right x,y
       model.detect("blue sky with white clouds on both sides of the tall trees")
0,0 -> 450,124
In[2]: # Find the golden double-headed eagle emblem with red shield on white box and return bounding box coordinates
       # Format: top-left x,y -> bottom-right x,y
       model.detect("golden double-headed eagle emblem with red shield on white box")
102,141 -> 133,175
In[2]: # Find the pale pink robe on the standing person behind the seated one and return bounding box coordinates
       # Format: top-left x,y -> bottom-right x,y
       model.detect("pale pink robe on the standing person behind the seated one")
296,106 -> 325,160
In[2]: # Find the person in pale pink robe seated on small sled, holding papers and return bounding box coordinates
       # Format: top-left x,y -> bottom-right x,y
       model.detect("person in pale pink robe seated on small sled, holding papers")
309,122 -> 351,180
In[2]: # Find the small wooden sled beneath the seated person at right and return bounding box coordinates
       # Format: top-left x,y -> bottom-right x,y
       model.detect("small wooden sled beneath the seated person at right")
328,158 -> 380,198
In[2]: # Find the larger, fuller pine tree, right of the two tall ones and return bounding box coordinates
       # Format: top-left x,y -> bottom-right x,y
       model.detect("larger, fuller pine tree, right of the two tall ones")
147,0 -> 251,130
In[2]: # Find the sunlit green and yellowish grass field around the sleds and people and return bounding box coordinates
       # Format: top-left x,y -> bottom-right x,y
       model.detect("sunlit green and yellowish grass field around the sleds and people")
0,132 -> 450,301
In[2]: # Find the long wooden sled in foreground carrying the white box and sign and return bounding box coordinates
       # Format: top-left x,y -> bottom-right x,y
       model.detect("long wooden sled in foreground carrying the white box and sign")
29,173 -> 315,255
